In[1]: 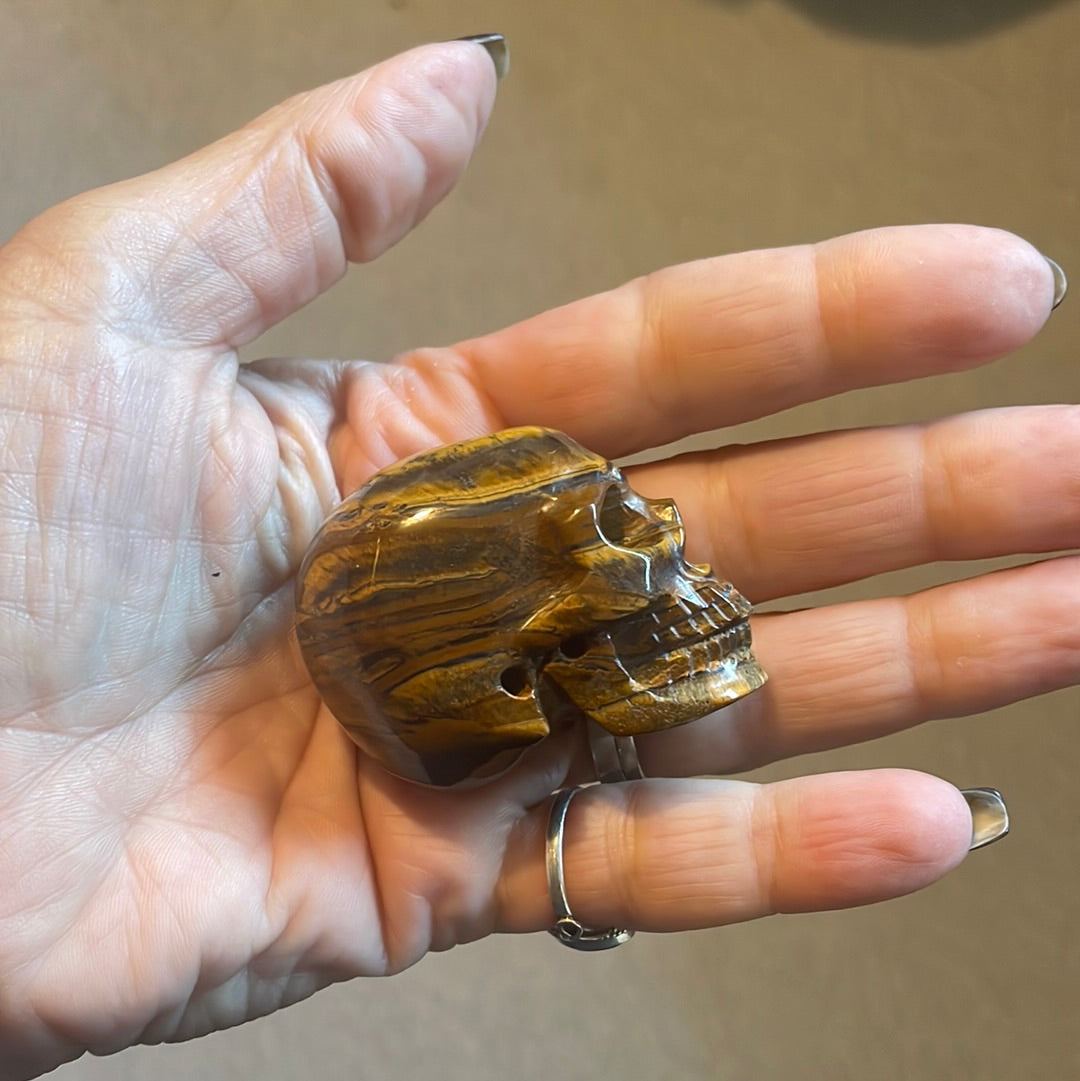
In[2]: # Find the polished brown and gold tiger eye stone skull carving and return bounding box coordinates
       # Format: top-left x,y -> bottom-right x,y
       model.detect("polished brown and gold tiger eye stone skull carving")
296,428 -> 765,786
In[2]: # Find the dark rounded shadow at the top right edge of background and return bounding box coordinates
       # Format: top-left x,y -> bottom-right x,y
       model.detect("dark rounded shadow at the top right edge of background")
711,0 -> 1068,42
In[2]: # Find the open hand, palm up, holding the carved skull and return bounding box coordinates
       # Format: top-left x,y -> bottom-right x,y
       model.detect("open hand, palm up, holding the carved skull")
0,43 -> 1080,1077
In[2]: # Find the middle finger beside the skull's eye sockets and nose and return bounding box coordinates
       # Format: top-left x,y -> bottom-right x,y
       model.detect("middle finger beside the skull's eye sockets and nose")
628,405 -> 1080,602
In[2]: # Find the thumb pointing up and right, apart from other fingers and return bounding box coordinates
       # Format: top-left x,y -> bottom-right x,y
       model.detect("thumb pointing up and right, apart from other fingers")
0,36 -> 505,348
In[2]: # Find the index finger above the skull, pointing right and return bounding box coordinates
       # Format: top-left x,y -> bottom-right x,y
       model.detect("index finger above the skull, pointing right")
456,225 -> 1055,457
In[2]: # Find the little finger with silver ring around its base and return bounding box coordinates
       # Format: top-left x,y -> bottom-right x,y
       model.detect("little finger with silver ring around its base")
497,770 -> 972,932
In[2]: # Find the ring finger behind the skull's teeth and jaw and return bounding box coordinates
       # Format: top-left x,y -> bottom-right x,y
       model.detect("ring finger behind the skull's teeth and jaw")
627,557 -> 1080,777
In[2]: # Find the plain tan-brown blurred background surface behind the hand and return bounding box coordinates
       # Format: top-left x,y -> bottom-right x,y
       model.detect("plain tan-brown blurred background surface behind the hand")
0,0 -> 1080,1081
